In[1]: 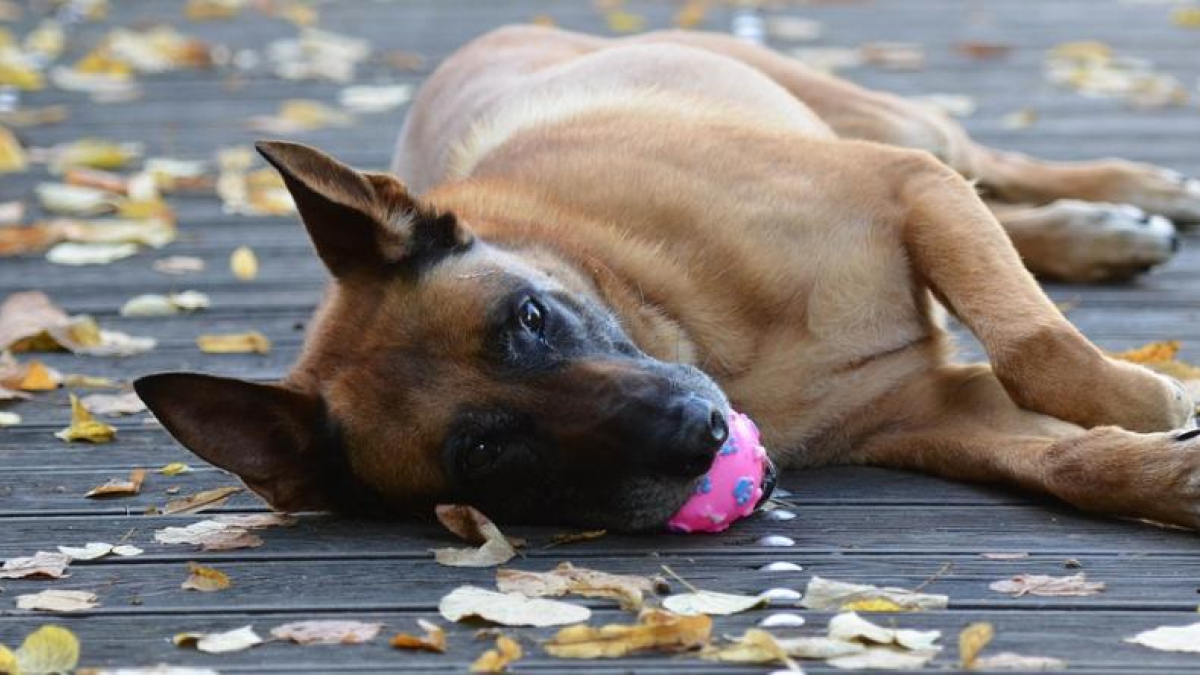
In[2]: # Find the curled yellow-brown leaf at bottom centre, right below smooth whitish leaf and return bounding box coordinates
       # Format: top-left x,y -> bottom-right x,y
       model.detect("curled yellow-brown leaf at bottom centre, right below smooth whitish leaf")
544,609 -> 713,658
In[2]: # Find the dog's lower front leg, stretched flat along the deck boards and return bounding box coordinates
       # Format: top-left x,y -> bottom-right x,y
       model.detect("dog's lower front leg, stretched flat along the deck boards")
848,365 -> 1200,527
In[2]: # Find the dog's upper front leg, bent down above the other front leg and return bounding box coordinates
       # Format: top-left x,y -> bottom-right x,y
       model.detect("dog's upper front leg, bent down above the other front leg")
880,151 -> 1193,431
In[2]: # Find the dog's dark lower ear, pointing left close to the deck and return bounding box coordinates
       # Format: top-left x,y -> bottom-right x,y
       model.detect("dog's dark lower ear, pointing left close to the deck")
133,372 -> 340,512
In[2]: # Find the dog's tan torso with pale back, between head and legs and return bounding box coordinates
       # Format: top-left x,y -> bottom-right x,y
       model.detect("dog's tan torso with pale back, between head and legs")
395,29 -> 944,465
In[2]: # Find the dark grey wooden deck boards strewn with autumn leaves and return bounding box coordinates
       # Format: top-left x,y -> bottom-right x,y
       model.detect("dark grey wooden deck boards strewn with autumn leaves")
0,0 -> 1200,673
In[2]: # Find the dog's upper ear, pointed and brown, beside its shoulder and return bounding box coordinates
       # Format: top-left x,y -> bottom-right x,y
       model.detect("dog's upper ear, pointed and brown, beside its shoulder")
254,141 -> 472,277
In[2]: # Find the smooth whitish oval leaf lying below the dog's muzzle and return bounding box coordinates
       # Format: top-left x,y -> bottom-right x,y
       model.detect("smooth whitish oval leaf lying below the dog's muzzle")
438,586 -> 592,627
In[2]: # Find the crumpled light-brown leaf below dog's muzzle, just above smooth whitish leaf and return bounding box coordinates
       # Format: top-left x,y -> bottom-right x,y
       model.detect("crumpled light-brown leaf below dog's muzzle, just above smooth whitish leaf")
496,562 -> 655,610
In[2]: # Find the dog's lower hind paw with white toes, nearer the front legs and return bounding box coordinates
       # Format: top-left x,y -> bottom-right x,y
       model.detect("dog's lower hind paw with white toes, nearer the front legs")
1006,199 -> 1180,282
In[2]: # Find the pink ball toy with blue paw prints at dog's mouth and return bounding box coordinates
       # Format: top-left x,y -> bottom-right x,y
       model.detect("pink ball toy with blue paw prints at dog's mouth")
667,411 -> 774,532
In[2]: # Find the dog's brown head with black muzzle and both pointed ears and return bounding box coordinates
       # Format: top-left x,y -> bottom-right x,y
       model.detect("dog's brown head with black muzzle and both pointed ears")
136,143 -> 727,530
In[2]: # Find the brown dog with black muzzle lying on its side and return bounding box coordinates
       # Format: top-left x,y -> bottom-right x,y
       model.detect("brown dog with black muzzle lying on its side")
136,26 -> 1200,531
